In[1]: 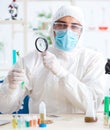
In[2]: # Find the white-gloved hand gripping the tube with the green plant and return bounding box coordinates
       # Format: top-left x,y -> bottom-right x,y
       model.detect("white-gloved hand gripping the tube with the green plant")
8,68 -> 26,89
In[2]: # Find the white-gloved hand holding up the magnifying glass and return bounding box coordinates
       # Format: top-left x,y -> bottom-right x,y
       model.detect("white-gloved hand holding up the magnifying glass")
42,51 -> 68,77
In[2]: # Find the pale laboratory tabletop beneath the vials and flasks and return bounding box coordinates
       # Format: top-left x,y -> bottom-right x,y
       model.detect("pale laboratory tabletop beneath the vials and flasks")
0,112 -> 107,130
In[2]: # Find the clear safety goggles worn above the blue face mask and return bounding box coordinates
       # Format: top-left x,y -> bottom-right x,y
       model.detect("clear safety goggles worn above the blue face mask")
53,22 -> 83,33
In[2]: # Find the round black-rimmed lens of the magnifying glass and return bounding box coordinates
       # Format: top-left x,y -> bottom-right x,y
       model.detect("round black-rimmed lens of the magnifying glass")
35,37 -> 48,52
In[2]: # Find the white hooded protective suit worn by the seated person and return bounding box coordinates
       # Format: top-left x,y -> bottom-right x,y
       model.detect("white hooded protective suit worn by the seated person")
0,6 -> 106,114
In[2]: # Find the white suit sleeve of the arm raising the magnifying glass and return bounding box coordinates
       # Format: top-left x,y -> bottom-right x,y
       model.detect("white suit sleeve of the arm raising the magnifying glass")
59,52 -> 106,111
